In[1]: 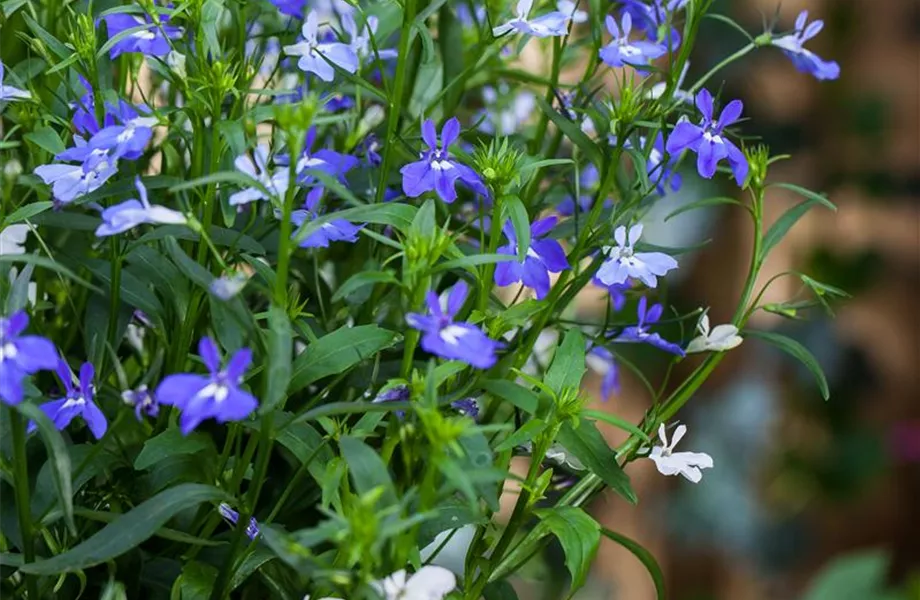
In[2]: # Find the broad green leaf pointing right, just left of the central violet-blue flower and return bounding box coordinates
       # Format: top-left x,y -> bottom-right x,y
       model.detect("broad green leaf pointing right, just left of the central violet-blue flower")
290,325 -> 398,394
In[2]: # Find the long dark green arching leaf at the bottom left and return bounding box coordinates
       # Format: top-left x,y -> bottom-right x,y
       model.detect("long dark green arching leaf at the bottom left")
20,483 -> 229,575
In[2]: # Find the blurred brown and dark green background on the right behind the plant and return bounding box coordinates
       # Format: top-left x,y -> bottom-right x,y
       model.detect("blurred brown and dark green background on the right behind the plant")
519,0 -> 920,600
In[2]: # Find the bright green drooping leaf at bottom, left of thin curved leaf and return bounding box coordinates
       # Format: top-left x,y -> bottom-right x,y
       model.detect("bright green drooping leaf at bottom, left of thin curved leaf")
534,506 -> 601,598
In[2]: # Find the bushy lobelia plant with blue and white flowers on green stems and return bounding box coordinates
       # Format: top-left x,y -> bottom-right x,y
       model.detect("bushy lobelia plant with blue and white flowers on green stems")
0,0 -> 843,600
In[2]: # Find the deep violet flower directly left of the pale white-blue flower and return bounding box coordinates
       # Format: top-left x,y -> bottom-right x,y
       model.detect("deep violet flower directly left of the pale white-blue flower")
495,217 -> 569,300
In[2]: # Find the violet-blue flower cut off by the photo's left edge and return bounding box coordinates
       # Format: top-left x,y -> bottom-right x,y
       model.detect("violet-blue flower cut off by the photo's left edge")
0,311 -> 60,405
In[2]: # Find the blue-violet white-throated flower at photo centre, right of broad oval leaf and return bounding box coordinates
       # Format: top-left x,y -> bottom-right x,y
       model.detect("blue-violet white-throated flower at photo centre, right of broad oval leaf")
406,280 -> 503,369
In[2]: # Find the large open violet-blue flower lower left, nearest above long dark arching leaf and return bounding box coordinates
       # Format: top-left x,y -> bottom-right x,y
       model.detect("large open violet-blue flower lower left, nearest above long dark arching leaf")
155,337 -> 259,435
